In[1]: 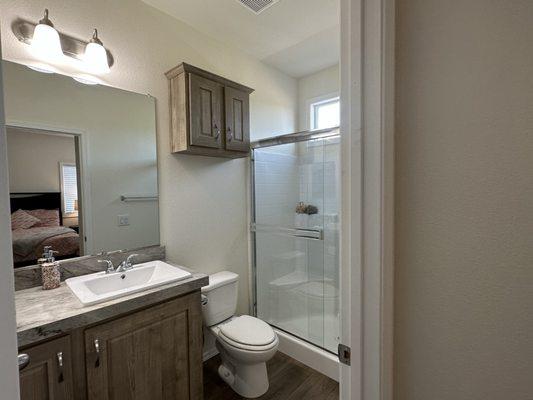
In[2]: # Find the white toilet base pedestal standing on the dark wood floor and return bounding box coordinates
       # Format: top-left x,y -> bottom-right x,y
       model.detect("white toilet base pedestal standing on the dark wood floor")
216,341 -> 269,399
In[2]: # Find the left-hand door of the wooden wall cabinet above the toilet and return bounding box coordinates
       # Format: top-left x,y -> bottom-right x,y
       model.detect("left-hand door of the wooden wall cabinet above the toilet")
189,74 -> 224,149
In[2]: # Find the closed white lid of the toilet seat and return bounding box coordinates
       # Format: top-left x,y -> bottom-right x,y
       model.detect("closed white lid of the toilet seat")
220,315 -> 276,346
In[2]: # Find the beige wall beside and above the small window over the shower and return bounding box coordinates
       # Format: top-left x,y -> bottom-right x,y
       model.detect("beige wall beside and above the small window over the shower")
298,65 -> 340,131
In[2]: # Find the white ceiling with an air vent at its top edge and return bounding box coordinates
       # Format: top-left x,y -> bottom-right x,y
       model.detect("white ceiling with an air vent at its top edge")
143,0 -> 340,78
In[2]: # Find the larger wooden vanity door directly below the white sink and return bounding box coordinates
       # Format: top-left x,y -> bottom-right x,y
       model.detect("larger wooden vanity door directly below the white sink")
85,292 -> 203,400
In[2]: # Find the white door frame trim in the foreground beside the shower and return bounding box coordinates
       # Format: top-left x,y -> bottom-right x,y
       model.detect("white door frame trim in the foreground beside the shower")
340,0 -> 395,400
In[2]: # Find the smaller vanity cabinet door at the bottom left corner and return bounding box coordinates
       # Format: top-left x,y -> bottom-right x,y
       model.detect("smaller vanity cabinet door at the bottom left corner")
19,336 -> 74,400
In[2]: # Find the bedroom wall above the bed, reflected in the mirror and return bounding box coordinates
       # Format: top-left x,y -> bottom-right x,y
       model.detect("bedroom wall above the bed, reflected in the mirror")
7,128 -> 76,192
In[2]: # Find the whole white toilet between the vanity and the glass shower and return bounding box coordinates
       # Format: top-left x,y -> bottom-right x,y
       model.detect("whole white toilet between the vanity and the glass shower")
202,271 -> 278,399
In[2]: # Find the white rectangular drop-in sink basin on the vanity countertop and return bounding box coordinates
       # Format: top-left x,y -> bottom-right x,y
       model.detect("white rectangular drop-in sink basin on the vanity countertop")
65,261 -> 192,306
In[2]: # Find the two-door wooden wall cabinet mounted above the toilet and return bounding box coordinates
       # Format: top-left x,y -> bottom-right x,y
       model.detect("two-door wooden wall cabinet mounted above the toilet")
166,63 -> 253,158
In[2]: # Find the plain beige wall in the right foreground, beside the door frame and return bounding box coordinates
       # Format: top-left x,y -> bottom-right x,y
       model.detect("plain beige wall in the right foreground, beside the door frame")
395,0 -> 533,400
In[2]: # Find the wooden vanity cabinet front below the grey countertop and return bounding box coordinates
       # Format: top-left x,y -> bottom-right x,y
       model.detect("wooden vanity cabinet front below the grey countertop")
20,291 -> 203,400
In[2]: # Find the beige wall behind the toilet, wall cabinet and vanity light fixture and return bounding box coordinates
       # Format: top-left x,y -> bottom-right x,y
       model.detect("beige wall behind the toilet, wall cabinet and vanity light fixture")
0,0 -> 297,312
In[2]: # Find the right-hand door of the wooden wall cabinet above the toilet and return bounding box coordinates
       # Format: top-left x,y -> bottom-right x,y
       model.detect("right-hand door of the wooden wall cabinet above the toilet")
224,87 -> 250,152
